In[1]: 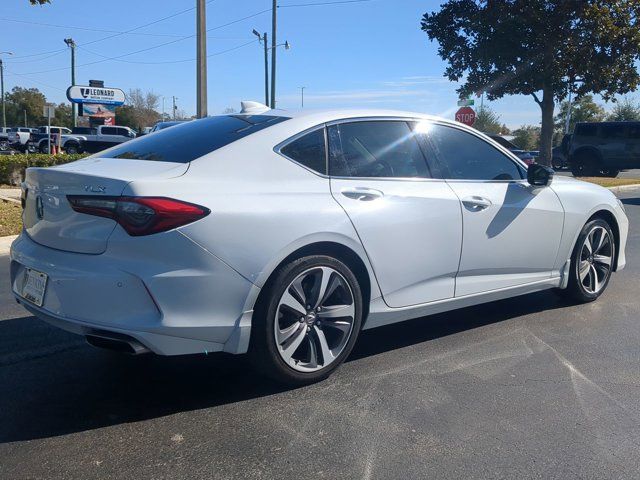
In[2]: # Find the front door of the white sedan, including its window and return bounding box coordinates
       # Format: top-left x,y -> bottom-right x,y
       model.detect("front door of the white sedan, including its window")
421,123 -> 564,297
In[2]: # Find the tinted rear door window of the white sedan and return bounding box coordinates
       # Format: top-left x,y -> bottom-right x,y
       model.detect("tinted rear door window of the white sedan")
327,121 -> 430,178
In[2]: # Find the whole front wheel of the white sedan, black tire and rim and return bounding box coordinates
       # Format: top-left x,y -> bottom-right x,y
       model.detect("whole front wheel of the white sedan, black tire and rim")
562,218 -> 616,303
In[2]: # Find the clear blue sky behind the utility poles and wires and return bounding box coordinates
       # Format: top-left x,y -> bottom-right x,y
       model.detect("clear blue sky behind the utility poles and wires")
0,0 -> 608,128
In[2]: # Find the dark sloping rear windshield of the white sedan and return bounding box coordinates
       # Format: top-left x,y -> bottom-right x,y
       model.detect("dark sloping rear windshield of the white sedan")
94,115 -> 288,163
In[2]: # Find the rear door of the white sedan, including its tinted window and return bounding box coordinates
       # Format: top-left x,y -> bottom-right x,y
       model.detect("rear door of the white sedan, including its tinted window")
327,119 -> 462,307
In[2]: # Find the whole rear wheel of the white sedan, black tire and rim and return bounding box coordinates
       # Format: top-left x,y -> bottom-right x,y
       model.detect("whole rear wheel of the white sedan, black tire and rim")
250,255 -> 363,385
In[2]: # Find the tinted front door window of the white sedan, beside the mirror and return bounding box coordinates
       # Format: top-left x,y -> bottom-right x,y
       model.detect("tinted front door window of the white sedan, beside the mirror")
425,125 -> 523,180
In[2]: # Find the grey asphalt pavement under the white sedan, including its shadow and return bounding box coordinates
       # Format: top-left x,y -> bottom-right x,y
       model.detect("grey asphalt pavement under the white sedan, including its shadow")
0,190 -> 640,479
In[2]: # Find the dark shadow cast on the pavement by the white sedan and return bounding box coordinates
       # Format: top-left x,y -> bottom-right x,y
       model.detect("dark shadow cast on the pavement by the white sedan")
0,292 -> 569,443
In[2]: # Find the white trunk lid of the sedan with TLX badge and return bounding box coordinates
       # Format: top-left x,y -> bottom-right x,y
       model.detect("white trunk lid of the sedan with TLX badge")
23,158 -> 189,254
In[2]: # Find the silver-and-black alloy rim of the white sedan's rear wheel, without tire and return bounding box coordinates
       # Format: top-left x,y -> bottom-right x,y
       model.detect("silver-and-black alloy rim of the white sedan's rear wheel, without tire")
274,267 -> 356,372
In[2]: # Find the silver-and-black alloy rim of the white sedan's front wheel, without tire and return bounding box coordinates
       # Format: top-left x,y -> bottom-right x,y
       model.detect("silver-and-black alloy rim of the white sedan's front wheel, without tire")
577,226 -> 614,294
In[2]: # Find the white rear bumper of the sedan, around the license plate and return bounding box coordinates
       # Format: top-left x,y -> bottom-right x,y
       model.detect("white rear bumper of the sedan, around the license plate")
11,230 -> 259,355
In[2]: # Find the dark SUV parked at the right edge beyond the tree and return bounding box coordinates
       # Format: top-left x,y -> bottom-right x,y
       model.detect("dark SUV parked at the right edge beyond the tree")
568,122 -> 640,177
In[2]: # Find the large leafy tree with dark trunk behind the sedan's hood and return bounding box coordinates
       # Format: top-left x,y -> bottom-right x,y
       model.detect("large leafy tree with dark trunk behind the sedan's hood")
422,0 -> 640,164
